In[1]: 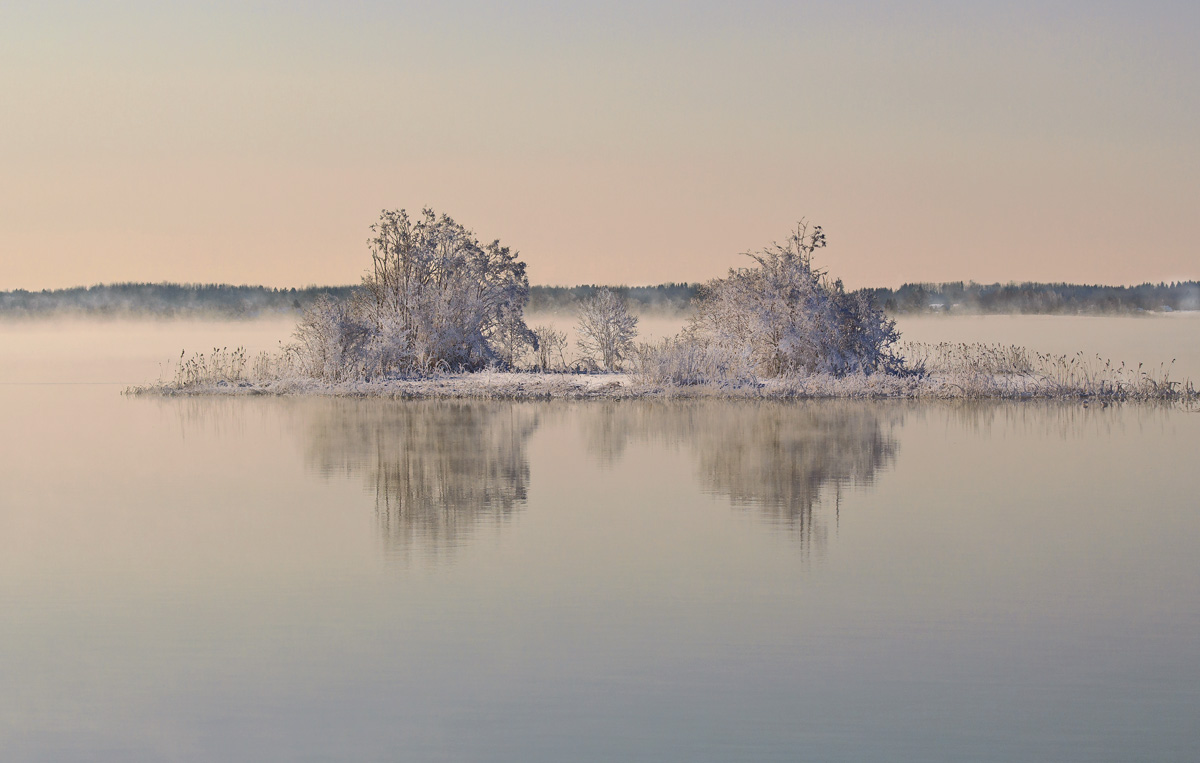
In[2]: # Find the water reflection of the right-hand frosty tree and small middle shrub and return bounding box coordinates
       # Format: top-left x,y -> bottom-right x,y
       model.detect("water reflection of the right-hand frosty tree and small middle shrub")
584,401 -> 901,546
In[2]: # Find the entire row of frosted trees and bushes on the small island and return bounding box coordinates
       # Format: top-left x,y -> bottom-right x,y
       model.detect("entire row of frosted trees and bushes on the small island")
283,209 -> 901,385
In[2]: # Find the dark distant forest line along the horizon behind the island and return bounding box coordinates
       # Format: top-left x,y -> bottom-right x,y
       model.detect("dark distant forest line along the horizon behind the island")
0,281 -> 1200,318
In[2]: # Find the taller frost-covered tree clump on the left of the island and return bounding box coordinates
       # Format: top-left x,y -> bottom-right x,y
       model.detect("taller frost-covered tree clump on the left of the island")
296,209 -> 536,378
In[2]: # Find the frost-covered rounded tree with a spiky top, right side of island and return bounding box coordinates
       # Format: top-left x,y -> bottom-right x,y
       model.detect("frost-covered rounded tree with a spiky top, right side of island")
689,221 -> 900,376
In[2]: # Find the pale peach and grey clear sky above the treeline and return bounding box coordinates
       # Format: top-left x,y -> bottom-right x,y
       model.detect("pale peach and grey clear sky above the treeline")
0,0 -> 1200,289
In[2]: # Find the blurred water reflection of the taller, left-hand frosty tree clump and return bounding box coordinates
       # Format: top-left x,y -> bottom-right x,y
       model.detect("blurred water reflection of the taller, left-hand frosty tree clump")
308,401 -> 538,553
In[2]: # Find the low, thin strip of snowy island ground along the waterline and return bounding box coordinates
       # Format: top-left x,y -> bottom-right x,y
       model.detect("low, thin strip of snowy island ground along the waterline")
125,371 -> 1198,402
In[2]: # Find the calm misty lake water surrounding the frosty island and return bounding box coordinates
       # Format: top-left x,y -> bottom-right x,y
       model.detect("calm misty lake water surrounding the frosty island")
0,317 -> 1200,762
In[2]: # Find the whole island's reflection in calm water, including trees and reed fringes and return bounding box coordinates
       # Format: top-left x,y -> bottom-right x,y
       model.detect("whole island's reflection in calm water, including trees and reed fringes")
160,398 -> 1170,557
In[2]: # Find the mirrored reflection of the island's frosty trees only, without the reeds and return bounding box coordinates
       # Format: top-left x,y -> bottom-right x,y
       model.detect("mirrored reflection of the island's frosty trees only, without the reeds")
297,401 -> 902,555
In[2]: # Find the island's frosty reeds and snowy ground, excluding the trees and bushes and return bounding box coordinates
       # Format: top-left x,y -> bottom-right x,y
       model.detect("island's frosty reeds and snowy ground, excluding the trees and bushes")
128,343 -> 1200,402
